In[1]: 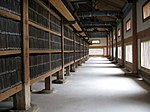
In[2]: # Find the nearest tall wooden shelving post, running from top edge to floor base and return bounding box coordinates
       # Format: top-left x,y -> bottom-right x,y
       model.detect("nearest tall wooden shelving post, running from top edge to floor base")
14,0 -> 31,110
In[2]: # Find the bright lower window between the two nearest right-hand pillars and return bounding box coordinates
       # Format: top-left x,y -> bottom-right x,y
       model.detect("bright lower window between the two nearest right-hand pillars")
126,45 -> 132,63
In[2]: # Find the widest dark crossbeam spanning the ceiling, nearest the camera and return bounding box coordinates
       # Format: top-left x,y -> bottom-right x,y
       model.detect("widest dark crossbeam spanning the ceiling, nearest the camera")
78,10 -> 122,17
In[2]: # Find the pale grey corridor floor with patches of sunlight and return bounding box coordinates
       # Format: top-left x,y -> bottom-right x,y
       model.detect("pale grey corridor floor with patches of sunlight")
32,58 -> 150,112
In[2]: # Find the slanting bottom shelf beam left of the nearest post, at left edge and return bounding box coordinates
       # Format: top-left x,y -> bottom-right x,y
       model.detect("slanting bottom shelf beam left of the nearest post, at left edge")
0,84 -> 22,101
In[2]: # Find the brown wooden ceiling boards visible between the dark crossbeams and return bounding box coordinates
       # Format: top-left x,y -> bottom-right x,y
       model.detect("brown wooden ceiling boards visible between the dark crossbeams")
70,0 -> 127,39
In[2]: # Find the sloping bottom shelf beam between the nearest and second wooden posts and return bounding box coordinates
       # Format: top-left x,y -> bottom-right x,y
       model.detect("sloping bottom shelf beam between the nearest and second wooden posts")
30,67 -> 62,85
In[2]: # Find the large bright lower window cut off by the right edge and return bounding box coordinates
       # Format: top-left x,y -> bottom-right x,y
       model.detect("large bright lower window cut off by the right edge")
141,40 -> 150,69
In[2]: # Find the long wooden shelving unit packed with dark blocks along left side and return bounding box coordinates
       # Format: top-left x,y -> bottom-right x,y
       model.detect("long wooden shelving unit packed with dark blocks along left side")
0,0 -> 88,110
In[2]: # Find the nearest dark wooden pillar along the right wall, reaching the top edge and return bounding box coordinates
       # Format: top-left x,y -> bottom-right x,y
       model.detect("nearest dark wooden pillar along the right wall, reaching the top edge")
132,0 -> 138,74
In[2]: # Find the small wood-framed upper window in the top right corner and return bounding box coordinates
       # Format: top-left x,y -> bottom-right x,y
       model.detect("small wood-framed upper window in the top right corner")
142,1 -> 150,21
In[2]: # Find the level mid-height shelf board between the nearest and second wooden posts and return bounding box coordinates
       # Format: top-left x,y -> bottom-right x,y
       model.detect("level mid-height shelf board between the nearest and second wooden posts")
29,50 -> 61,54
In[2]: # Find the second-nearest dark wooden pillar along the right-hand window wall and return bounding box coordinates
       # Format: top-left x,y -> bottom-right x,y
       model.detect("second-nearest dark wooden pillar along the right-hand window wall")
121,19 -> 125,67
